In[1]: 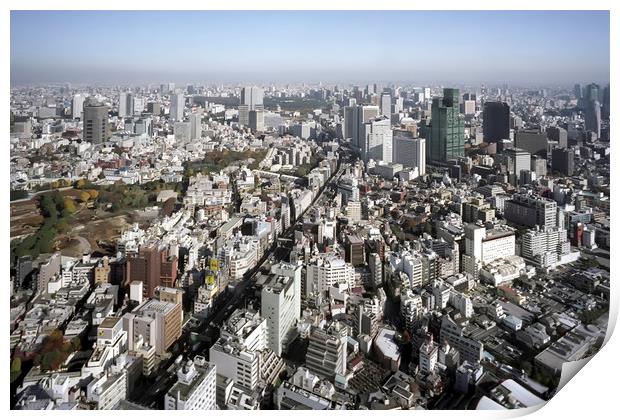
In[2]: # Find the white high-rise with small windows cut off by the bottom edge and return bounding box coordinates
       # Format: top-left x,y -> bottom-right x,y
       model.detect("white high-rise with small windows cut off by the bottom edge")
164,356 -> 217,410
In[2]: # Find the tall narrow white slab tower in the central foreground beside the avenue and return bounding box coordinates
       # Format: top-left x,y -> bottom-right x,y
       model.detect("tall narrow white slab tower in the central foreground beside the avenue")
261,272 -> 301,356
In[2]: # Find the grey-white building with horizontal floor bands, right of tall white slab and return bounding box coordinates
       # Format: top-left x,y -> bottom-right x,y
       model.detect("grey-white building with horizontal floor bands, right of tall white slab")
306,322 -> 347,378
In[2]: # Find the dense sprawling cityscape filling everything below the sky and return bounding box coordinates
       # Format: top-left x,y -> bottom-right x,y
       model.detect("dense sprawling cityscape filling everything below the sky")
10,83 -> 610,410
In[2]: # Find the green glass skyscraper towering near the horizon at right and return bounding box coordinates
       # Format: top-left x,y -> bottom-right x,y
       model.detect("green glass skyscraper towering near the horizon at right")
427,88 -> 465,162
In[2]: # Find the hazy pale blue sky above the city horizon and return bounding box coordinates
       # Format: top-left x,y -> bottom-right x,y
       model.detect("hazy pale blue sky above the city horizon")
11,11 -> 609,84
